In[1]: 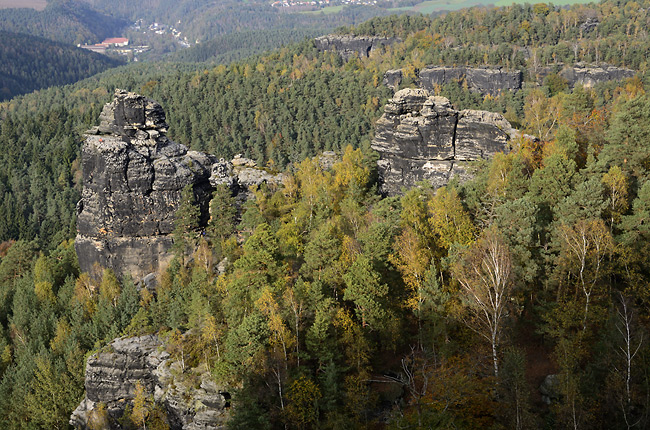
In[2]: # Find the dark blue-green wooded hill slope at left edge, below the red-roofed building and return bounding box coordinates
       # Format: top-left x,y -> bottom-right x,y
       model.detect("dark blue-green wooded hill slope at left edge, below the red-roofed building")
0,31 -> 123,101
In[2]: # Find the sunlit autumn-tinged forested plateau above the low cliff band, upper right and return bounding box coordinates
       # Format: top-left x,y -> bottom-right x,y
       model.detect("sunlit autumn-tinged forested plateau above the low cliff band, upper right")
346,2 -> 649,69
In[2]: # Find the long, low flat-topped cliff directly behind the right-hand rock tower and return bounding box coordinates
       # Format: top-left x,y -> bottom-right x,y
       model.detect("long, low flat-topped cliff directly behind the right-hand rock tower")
418,67 -> 522,95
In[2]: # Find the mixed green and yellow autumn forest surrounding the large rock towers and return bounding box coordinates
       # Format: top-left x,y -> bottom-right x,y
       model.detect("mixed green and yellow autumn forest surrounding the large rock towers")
0,1 -> 650,429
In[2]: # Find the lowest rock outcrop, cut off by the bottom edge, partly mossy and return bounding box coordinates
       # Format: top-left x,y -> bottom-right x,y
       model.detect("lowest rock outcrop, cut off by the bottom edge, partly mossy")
70,335 -> 230,430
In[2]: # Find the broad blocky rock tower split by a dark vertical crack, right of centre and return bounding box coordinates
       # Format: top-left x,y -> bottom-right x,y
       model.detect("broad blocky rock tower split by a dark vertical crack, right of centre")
372,89 -> 517,195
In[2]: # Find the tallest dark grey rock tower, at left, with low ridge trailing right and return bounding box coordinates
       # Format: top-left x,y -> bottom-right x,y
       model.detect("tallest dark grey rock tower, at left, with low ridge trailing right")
75,90 -> 280,280
